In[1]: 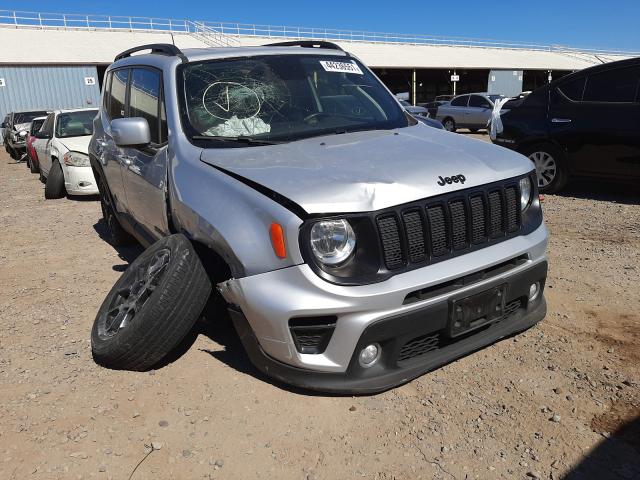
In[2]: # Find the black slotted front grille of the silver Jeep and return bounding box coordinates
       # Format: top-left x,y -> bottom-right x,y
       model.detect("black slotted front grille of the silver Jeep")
376,182 -> 521,270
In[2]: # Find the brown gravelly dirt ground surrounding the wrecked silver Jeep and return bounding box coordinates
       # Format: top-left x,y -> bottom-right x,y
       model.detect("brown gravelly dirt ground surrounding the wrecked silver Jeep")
0,137 -> 640,480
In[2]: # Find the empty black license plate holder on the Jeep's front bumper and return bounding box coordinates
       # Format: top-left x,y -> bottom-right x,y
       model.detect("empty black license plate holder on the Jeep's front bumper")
448,285 -> 507,337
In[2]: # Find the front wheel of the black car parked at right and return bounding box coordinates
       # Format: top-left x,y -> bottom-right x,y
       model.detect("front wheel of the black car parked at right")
522,143 -> 569,193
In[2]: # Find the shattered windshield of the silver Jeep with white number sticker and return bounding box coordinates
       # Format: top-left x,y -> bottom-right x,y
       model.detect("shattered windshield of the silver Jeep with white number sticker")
182,55 -> 408,142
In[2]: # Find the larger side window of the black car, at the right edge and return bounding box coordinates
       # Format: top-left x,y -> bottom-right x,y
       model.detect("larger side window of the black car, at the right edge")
583,67 -> 640,102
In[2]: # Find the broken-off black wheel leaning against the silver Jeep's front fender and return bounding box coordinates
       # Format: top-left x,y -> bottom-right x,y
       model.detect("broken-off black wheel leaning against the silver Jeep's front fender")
91,234 -> 211,371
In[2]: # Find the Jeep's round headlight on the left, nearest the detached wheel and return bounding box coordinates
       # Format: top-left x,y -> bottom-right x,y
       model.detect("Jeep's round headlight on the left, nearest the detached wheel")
311,220 -> 356,265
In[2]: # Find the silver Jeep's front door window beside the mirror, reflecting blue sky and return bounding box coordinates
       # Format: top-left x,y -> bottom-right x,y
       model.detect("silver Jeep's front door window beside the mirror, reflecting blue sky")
128,68 -> 166,144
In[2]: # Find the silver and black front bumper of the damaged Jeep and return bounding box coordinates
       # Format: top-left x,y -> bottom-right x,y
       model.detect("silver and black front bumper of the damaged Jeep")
219,224 -> 547,392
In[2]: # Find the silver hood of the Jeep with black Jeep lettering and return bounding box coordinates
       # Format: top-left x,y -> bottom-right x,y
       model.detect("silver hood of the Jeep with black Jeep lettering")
201,124 -> 532,213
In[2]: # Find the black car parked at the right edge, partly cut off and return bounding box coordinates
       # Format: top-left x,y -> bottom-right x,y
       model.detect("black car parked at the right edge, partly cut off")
494,58 -> 640,193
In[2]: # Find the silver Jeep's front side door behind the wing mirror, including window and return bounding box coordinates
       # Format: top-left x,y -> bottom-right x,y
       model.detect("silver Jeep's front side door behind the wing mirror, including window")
119,67 -> 168,241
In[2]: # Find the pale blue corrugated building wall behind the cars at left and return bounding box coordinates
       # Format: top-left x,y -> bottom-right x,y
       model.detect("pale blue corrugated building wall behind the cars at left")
0,65 -> 100,140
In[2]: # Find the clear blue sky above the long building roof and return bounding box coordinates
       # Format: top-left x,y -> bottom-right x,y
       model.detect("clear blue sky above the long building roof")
11,0 -> 640,52
